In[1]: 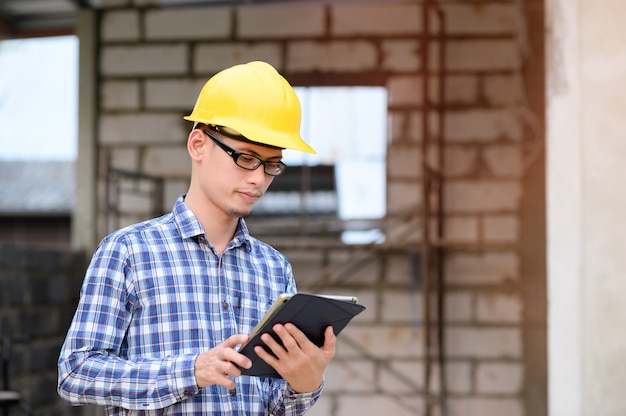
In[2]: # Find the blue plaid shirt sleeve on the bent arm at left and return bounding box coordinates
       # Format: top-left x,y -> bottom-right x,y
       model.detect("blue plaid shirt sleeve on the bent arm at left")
57,240 -> 199,410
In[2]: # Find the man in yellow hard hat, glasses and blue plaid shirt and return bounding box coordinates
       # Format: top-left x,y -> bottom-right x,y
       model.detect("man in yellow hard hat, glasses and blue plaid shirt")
58,62 -> 336,415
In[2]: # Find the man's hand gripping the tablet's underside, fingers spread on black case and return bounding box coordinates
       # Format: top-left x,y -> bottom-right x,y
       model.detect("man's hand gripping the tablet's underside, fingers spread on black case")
254,323 -> 337,393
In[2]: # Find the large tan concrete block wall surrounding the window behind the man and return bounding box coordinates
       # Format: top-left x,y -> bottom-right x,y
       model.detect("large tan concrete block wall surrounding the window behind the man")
90,0 -> 528,416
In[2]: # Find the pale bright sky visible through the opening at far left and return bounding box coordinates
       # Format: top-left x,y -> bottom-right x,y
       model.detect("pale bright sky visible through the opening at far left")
0,36 -> 78,161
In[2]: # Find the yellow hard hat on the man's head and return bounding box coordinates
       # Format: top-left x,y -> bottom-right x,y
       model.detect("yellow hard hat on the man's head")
184,61 -> 316,153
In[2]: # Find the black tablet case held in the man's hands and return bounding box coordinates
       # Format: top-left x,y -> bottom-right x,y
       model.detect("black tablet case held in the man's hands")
239,293 -> 365,378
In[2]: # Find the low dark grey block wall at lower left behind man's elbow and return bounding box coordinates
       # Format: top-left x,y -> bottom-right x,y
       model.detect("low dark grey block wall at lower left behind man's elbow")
0,244 -> 86,416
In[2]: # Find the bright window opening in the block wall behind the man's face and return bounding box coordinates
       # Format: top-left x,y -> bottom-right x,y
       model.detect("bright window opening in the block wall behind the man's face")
254,86 -> 387,243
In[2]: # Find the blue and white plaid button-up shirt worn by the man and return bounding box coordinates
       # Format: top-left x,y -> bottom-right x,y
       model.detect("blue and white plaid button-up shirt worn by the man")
58,197 -> 322,416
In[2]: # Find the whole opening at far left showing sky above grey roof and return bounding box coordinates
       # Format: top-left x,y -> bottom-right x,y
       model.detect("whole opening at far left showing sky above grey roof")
0,36 -> 78,248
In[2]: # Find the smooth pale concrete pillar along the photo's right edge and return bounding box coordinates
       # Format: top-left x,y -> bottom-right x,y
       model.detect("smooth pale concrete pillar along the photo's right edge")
546,0 -> 626,416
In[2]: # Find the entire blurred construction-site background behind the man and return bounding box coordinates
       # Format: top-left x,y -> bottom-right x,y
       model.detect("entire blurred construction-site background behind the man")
0,0 -> 626,416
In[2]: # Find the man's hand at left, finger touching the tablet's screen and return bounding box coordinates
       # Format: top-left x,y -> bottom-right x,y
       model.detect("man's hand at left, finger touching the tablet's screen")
195,334 -> 252,389
